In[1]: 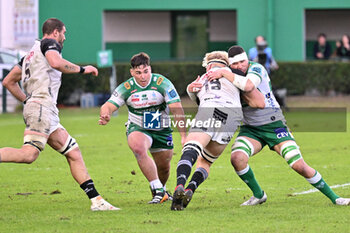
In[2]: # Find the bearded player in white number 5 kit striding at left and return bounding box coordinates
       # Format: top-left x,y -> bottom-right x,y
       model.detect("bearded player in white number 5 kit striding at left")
0,18 -> 119,211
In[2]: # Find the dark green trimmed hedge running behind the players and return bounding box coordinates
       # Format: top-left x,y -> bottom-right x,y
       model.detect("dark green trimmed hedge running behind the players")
58,61 -> 350,103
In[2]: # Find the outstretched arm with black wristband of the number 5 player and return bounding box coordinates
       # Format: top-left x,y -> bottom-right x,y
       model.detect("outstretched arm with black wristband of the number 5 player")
45,51 -> 98,76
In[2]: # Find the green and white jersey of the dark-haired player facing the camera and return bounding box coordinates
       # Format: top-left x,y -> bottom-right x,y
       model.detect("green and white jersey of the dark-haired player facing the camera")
108,74 -> 180,129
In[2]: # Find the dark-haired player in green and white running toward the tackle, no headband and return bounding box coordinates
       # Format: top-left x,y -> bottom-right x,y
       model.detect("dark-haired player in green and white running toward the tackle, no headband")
99,53 -> 186,204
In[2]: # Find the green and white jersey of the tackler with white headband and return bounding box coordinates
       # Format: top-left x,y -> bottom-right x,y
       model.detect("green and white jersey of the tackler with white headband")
242,61 -> 285,126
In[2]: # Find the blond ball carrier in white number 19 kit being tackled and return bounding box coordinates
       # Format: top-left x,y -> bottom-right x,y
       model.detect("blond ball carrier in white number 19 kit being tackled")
171,51 -> 266,210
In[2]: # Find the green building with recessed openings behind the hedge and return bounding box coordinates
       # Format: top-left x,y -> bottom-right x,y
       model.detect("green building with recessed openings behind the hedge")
39,0 -> 350,62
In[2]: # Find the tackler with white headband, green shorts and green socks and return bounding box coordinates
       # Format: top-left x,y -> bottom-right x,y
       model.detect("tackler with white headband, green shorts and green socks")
211,46 -> 350,206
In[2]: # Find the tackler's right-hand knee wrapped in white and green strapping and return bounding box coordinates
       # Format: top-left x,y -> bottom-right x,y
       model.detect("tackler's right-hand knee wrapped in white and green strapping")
280,141 -> 303,167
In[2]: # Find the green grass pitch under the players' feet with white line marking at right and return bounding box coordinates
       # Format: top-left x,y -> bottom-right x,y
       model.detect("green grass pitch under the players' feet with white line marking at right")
0,103 -> 350,232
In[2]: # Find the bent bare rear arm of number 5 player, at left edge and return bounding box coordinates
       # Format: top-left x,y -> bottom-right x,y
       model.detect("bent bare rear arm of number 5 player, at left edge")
2,65 -> 26,102
